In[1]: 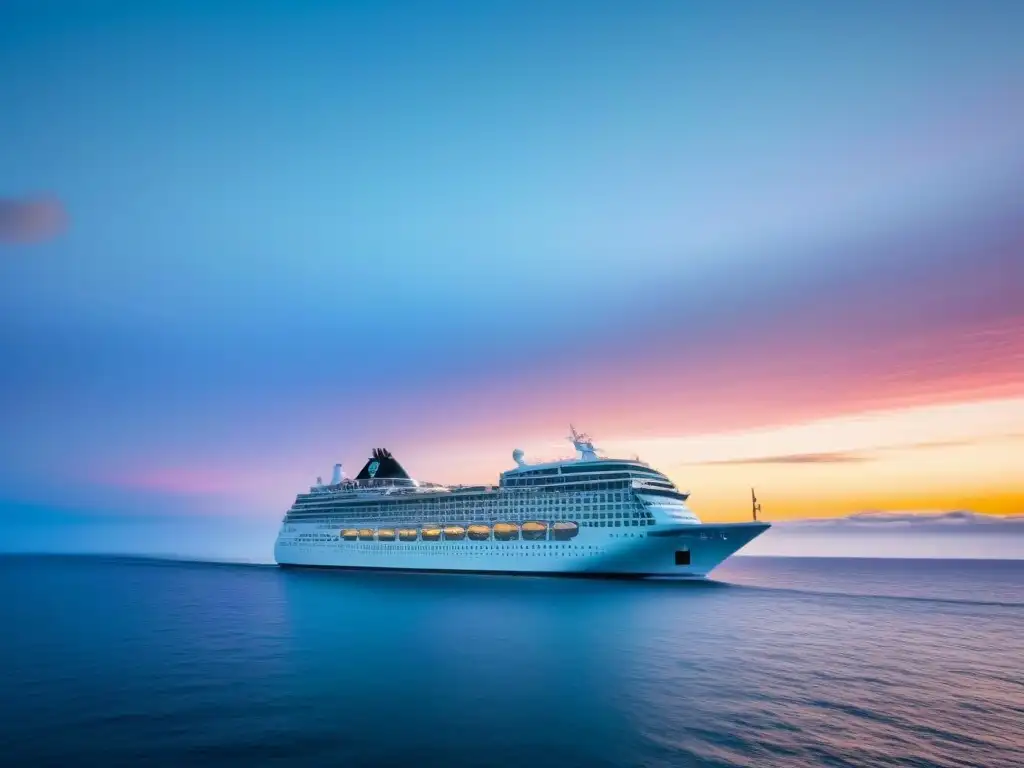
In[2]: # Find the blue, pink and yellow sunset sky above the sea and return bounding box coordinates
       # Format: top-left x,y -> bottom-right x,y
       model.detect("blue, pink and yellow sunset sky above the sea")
0,0 -> 1024,557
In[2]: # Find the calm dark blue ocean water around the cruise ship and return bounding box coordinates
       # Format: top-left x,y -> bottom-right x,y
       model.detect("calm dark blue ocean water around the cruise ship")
0,557 -> 1024,768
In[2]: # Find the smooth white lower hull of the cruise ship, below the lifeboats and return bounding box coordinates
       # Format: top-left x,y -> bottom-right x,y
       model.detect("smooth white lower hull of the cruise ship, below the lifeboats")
274,522 -> 769,579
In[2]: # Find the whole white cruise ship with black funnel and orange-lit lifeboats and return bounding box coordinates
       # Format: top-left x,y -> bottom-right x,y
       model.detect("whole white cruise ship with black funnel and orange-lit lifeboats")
274,429 -> 769,579
